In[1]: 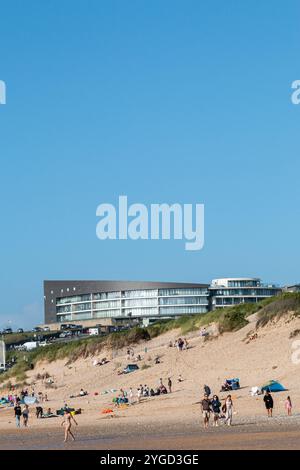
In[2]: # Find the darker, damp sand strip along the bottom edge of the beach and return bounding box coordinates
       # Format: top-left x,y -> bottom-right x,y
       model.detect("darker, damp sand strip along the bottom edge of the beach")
0,423 -> 300,450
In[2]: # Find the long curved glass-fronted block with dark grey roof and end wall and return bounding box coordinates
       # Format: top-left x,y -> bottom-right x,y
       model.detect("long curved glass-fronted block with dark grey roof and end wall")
44,281 -> 209,324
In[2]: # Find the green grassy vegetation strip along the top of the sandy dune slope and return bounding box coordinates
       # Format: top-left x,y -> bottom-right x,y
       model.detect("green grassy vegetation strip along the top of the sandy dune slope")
0,293 -> 300,390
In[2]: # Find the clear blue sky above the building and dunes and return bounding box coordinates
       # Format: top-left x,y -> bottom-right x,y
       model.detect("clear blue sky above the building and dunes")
0,0 -> 300,327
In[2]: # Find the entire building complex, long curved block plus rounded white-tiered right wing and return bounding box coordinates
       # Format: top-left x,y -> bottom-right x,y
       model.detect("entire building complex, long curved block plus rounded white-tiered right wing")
44,278 -> 281,324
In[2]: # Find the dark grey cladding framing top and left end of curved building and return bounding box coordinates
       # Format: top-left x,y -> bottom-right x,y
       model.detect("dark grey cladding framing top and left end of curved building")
44,281 -> 209,323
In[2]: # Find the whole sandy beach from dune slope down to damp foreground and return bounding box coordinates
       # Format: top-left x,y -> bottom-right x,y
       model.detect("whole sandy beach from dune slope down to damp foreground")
0,318 -> 300,449
